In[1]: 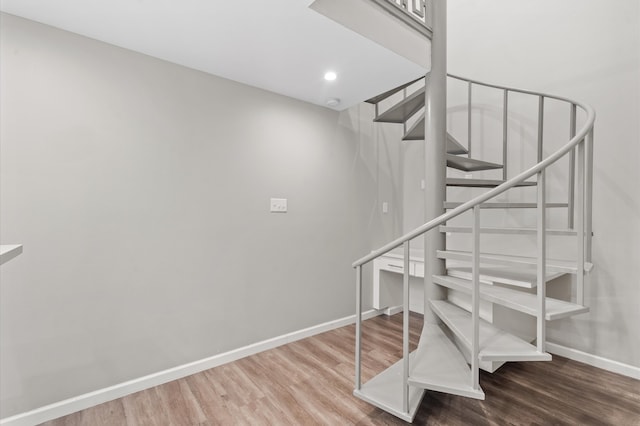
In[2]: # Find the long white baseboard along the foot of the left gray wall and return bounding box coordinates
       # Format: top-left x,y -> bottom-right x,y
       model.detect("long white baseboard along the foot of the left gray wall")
0,309 -> 382,426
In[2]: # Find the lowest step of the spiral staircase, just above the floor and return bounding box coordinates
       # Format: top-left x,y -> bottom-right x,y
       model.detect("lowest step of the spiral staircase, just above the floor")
353,352 -> 425,423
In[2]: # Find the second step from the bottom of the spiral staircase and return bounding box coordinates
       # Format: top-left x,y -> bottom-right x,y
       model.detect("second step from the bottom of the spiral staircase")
409,323 -> 484,399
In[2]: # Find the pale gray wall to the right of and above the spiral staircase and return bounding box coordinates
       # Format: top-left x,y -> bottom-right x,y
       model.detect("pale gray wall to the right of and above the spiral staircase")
448,0 -> 640,366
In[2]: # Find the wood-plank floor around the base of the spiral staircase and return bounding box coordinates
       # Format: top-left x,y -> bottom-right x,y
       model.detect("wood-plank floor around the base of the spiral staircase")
45,314 -> 640,426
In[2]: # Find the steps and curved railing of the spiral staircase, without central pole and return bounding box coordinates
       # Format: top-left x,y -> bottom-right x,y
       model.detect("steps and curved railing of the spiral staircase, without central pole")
353,70 -> 595,422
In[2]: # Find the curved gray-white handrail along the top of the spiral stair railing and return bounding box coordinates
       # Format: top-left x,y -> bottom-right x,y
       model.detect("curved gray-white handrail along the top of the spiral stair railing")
351,74 -> 596,268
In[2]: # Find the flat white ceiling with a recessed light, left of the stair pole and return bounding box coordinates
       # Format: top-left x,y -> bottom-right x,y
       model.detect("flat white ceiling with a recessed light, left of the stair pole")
0,0 -> 425,110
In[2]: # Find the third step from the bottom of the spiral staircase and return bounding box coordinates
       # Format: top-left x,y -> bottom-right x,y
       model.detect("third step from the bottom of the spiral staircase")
429,300 -> 551,361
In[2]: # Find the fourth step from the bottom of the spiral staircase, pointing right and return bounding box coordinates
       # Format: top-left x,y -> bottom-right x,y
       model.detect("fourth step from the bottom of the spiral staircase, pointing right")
433,275 -> 589,321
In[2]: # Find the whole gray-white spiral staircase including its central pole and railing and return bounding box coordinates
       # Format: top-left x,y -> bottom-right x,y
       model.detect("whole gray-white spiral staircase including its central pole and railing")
316,0 -> 595,422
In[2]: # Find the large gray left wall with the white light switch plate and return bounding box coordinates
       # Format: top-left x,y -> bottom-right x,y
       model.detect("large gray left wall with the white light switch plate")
0,15 -> 386,417
